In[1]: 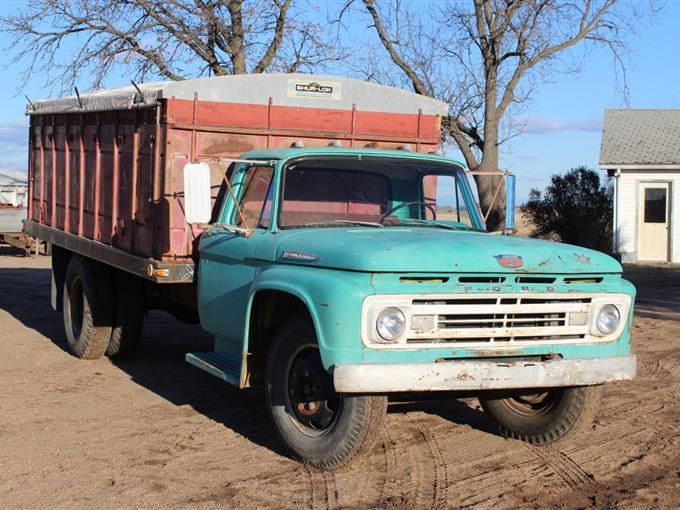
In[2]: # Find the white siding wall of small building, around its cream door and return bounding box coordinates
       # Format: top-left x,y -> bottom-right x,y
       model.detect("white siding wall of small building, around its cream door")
614,170 -> 680,262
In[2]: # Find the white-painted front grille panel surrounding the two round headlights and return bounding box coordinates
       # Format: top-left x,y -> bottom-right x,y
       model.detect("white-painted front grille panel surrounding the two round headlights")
362,293 -> 630,349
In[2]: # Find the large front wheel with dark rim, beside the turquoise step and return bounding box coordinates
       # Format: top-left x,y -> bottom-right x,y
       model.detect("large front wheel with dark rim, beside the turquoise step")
266,314 -> 387,469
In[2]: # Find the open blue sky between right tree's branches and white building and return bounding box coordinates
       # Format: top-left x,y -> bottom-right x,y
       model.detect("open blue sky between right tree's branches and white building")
492,0 -> 680,201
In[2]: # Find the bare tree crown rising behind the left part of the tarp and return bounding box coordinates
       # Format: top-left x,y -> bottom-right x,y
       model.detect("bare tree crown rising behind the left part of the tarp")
0,0 -> 339,92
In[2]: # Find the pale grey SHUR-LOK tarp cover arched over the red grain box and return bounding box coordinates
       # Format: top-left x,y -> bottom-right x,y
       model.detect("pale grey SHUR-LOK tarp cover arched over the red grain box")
26,73 -> 448,115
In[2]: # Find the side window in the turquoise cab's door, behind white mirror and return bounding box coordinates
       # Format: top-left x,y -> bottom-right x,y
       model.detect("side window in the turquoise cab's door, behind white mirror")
234,166 -> 274,228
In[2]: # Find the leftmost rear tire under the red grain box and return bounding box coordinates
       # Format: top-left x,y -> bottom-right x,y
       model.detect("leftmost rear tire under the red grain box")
63,255 -> 113,359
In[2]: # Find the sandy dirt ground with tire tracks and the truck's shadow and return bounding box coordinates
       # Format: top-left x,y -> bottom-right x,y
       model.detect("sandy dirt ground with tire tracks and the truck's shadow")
0,248 -> 680,509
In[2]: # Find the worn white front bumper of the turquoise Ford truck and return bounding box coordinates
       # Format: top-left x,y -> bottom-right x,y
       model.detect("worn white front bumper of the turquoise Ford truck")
333,355 -> 636,393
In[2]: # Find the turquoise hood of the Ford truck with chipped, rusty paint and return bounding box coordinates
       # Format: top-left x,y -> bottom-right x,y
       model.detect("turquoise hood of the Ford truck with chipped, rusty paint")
276,227 -> 621,274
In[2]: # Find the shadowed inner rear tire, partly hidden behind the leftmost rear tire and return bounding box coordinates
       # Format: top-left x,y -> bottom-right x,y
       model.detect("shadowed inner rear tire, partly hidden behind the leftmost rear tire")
106,271 -> 146,359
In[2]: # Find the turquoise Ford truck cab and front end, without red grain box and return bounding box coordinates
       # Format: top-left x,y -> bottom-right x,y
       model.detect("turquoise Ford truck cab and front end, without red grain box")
184,148 -> 636,469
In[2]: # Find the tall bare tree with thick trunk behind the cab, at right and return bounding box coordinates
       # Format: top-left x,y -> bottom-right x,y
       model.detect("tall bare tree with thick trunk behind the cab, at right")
358,0 -> 638,229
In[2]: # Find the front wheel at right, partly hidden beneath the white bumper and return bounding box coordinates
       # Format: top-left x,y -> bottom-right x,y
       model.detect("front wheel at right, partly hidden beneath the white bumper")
479,386 -> 602,445
